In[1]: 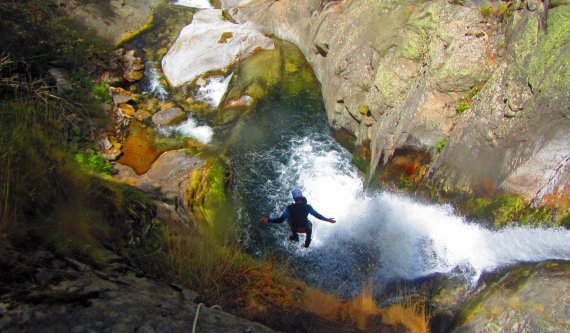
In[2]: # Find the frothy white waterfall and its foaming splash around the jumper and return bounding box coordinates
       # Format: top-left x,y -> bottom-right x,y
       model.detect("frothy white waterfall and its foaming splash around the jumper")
269,138 -> 570,281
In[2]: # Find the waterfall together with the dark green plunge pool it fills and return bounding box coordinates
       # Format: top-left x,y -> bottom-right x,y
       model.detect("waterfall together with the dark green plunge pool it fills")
232,87 -> 570,296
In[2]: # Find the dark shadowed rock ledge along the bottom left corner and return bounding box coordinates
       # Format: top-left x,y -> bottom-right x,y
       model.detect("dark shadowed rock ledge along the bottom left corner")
0,251 -> 280,333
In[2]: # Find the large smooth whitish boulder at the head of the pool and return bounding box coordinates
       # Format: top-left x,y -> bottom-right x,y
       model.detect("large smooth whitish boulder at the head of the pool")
162,9 -> 274,87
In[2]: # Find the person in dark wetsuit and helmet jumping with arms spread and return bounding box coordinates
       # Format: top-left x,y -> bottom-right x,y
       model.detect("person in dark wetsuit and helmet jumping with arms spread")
261,188 -> 336,247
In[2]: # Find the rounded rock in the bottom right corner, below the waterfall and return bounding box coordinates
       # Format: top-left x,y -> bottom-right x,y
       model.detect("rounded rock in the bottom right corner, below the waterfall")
453,263 -> 570,333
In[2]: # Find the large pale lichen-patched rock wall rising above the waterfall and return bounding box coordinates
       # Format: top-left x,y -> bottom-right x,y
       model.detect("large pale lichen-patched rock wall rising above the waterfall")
223,0 -> 570,203
